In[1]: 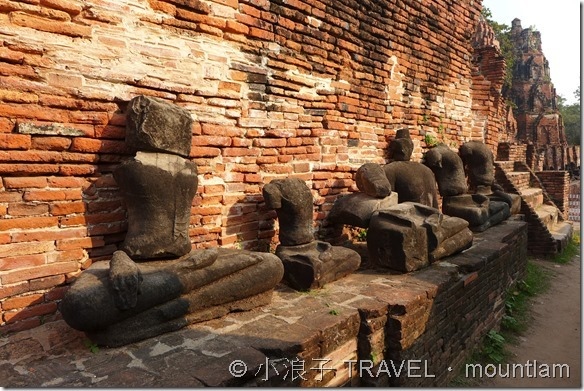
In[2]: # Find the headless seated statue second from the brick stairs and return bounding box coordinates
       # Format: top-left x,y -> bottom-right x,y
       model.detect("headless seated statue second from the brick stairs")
424,144 -> 510,232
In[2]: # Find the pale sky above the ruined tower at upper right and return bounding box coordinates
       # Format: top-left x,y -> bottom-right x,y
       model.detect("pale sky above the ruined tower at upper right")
483,0 -> 581,104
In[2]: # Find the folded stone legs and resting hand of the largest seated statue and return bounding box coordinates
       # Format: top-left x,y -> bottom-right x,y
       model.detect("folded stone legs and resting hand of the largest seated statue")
60,249 -> 284,346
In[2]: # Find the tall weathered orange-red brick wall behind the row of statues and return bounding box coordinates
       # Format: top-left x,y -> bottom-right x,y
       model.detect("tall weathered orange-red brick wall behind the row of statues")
0,0 -> 493,331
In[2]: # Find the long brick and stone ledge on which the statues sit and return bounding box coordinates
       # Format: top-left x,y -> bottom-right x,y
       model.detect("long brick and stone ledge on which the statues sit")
0,221 -> 527,387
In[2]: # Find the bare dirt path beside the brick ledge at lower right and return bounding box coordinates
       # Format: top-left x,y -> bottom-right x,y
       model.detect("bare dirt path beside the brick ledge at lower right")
482,243 -> 582,388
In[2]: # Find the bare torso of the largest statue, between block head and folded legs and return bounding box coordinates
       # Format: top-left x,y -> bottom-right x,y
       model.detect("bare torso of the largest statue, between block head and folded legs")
114,152 -> 197,259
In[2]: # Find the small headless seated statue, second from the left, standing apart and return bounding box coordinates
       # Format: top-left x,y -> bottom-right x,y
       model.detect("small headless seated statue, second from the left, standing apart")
263,178 -> 361,291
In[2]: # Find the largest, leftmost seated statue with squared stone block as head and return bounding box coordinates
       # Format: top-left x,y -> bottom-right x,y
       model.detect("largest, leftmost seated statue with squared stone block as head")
60,96 -> 284,346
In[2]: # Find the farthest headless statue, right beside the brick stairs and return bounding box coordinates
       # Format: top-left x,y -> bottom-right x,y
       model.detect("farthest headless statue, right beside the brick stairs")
458,141 -> 521,215
